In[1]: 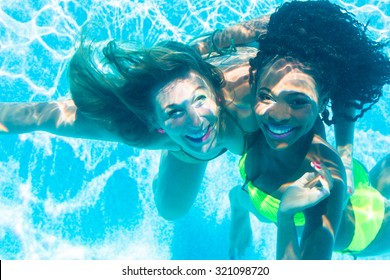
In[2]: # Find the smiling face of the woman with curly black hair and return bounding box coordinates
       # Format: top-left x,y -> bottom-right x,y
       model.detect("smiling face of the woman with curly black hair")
254,59 -> 325,149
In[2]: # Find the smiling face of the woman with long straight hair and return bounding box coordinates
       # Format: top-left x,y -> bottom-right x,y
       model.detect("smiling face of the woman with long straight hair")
155,71 -> 221,159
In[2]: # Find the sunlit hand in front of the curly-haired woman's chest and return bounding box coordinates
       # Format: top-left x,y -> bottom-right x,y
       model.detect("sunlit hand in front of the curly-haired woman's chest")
278,162 -> 333,216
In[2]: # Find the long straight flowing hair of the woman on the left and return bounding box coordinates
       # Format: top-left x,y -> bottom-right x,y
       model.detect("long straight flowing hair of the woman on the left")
69,35 -> 224,146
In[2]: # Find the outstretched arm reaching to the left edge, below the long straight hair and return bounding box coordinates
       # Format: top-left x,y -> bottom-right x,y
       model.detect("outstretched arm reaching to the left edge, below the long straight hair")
0,100 -> 177,150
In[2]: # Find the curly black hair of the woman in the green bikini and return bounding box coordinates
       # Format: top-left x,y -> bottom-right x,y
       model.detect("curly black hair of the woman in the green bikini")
251,1 -> 390,125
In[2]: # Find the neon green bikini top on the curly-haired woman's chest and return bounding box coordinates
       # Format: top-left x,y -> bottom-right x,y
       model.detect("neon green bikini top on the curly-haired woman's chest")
239,153 -> 305,226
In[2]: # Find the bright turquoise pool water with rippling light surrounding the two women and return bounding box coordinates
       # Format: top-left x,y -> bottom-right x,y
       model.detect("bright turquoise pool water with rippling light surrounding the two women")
0,0 -> 390,259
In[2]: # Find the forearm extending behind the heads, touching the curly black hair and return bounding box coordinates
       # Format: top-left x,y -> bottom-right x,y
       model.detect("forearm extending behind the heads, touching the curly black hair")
190,16 -> 269,54
